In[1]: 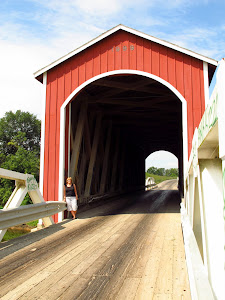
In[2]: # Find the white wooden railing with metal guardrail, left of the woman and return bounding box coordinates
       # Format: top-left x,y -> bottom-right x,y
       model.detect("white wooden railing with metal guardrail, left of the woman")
0,168 -> 66,241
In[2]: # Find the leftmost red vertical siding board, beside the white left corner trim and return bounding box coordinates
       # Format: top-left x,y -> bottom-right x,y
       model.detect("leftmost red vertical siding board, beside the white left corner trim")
43,81 -> 51,201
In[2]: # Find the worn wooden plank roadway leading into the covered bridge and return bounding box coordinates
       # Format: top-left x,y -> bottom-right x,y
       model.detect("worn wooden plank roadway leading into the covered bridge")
0,181 -> 191,300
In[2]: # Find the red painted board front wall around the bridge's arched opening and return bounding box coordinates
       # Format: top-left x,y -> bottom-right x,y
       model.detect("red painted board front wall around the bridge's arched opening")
44,30 -> 205,220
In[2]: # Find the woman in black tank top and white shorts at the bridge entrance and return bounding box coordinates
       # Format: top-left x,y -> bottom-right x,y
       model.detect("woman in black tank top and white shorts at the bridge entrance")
64,177 -> 78,220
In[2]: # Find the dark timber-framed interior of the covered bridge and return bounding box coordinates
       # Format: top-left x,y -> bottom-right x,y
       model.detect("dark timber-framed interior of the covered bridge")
69,75 -> 183,202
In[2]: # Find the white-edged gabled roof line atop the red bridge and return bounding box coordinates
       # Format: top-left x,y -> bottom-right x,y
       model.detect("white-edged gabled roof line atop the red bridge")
34,24 -> 218,77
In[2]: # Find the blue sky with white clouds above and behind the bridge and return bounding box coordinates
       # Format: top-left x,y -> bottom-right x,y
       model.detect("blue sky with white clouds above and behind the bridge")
0,0 -> 225,169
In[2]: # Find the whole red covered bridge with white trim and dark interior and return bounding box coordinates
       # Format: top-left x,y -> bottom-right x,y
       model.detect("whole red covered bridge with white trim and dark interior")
35,25 -> 217,221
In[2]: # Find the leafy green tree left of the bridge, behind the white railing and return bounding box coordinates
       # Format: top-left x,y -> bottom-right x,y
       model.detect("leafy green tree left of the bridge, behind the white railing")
0,110 -> 41,208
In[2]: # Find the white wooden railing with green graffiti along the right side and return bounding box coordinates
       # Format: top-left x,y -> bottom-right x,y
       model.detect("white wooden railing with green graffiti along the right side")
181,59 -> 225,300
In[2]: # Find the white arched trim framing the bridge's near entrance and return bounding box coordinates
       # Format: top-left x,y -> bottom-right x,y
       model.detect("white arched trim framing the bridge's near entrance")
58,70 -> 188,201
